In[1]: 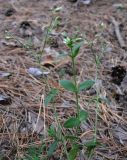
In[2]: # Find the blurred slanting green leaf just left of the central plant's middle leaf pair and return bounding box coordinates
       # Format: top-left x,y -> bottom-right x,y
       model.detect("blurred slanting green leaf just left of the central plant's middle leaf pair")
44,88 -> 58,106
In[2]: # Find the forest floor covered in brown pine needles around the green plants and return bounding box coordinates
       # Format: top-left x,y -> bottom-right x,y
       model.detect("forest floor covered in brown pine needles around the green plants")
0,0 -> 127,160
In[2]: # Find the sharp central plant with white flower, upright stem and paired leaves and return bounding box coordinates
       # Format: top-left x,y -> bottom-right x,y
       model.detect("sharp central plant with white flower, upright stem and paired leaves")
60,37 -> 94,125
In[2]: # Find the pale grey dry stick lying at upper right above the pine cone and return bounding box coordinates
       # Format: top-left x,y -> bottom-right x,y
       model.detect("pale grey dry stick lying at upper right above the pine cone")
111,17 -> 126,48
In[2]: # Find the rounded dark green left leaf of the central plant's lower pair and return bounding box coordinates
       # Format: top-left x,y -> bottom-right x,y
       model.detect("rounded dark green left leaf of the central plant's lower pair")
64,117 -> 81,128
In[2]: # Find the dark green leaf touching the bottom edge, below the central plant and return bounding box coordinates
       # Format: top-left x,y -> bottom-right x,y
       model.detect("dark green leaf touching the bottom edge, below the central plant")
69,144 -> 80,160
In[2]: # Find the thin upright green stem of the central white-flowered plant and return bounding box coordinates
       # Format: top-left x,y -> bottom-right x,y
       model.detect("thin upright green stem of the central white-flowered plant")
72,58 -> 80,118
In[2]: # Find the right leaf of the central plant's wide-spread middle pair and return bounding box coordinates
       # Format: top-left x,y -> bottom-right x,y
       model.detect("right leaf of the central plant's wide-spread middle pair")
79,80 -> 95,91
